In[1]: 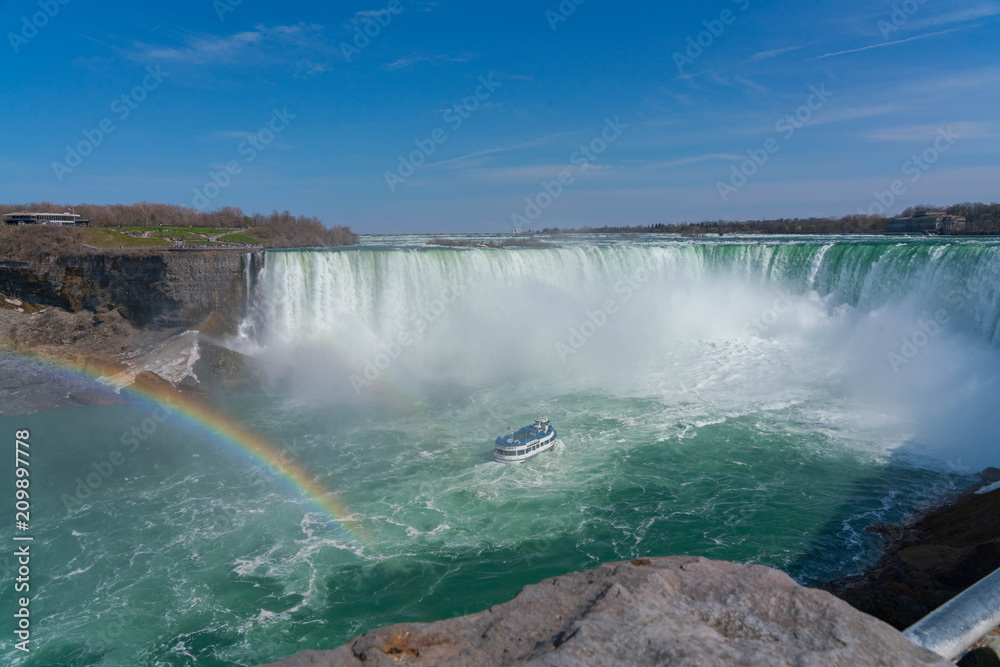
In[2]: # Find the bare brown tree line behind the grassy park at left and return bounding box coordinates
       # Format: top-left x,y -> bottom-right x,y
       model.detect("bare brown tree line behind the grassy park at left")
0,202 -> 357,248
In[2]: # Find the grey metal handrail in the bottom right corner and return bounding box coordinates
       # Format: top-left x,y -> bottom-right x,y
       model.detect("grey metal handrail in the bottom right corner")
903,570 -> 1000,660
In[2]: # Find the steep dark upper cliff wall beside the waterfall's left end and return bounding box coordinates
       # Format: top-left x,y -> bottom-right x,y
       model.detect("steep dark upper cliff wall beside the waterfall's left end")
0,251 -> 262,333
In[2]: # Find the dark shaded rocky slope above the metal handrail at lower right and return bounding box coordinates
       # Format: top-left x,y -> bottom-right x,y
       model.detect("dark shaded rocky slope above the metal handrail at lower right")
827,468 -> 1000,629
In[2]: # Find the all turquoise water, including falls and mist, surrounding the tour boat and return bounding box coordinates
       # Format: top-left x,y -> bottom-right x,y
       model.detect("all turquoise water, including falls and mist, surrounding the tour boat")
0,238 -> 1000,666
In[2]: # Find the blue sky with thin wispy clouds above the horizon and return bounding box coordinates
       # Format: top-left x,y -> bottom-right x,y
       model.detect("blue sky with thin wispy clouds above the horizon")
0,0 -> 1000,233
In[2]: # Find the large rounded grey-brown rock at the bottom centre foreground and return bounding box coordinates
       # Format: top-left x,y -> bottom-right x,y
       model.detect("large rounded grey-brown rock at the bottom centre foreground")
258,557 -> 950,667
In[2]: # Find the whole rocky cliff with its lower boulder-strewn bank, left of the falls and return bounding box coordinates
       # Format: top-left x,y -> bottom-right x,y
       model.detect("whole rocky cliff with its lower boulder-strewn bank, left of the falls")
0,251 -> 263,415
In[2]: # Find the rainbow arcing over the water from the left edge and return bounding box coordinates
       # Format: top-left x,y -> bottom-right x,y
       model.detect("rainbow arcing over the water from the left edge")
0,349 -> 371,546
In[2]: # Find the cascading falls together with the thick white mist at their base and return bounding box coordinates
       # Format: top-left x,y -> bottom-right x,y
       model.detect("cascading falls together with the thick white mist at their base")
248,240 -> 1000,412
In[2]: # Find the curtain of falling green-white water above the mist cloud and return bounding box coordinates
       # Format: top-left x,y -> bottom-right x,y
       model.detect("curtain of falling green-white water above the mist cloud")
248,241 -> 1000,344
